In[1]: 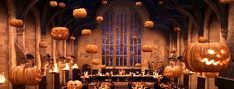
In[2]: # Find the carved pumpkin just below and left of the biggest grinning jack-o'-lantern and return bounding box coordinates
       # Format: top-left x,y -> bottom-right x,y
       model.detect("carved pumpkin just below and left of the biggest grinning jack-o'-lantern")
163,65 -> 182,78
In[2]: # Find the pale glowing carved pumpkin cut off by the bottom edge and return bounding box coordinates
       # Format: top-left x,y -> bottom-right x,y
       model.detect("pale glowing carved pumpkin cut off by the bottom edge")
67,80 -> 83,89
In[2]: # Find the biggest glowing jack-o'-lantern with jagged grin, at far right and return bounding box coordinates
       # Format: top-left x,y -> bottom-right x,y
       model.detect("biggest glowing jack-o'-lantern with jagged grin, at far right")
185,42 -> 230,72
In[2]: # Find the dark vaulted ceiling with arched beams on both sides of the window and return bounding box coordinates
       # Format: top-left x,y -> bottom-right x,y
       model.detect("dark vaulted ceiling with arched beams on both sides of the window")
15,0 -> 228,38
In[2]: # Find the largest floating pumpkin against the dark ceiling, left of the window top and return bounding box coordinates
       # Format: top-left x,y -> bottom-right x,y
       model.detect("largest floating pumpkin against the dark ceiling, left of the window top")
73,8 -> 87,19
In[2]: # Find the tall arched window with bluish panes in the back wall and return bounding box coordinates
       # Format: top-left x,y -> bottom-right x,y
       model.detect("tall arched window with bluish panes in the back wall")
101,6 -> 143,67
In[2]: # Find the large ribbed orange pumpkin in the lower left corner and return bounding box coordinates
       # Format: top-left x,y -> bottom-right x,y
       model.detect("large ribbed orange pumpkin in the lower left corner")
9,66 -> 41,85
